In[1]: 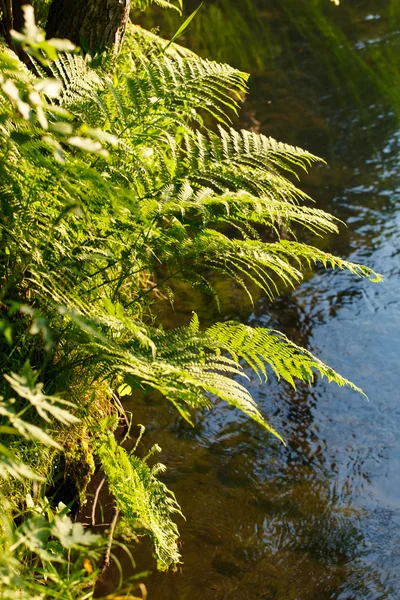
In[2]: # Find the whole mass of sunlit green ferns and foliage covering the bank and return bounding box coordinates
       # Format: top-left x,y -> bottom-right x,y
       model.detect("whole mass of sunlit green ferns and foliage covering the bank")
0,5 -> 379,597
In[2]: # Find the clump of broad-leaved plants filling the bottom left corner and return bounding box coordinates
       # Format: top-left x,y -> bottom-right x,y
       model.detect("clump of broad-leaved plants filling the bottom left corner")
0,496 -> 102,600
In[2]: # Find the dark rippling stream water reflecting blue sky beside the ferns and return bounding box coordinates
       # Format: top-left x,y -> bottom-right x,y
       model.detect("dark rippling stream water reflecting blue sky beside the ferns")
123,0 -> 400,600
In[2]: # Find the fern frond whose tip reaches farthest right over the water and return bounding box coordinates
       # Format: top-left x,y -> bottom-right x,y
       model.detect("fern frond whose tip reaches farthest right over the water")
148,222 -> 380,299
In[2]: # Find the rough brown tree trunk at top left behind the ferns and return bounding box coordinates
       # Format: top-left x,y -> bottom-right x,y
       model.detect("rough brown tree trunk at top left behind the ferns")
45,0 -> 131,53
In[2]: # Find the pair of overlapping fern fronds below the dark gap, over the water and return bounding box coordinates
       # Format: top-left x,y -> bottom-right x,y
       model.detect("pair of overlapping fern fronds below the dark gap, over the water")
86,317 -> 363,441
